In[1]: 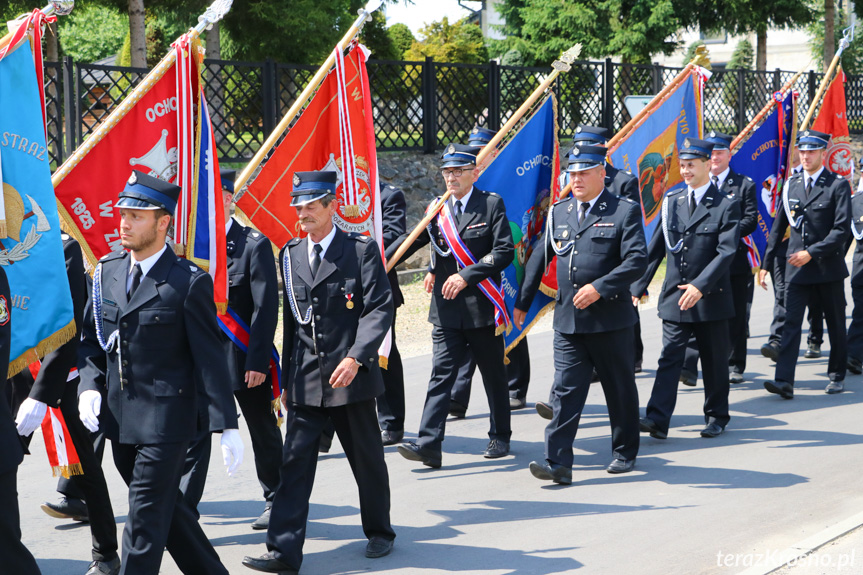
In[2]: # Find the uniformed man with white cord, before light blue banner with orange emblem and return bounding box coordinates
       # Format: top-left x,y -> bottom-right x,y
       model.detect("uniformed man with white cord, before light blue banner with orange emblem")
632,138 -> 740,439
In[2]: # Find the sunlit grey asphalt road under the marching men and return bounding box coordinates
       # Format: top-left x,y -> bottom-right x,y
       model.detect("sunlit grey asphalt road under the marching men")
15,289 -> 863,575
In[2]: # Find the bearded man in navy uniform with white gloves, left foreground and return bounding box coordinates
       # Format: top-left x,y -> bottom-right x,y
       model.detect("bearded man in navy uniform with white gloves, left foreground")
78,171 -> 243,575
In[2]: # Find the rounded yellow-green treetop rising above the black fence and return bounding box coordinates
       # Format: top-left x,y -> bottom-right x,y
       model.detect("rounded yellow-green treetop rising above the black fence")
404,17 -> 488,64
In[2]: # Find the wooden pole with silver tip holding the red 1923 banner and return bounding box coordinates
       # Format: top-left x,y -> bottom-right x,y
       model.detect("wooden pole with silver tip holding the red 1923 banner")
51,0 -> 233,188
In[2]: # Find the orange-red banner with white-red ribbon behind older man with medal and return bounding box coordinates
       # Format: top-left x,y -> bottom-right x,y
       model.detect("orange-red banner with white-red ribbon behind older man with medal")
237,42 -> 380,246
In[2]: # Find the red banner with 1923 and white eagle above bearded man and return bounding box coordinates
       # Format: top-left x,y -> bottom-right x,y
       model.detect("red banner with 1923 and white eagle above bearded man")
55,38 -> 200,264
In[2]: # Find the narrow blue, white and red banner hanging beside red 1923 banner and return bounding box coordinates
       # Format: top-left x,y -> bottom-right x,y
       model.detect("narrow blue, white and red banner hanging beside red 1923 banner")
187,90 -> 228,314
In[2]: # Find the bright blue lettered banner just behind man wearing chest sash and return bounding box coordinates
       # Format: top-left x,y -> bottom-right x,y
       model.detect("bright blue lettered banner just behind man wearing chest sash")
476,95 -> 560,352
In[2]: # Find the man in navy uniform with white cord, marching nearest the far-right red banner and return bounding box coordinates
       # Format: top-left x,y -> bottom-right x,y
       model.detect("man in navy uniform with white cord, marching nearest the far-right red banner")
758,130 -> 851,399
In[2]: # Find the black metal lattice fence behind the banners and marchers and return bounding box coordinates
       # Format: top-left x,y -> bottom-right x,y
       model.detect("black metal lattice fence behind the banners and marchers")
40,57 -> 863,166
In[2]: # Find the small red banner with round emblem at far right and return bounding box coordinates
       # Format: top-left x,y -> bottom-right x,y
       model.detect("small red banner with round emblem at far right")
812,66 -> 854,189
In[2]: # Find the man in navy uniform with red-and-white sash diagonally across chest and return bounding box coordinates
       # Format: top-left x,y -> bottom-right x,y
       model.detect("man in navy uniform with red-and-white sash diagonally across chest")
386,144 -> 515,468
